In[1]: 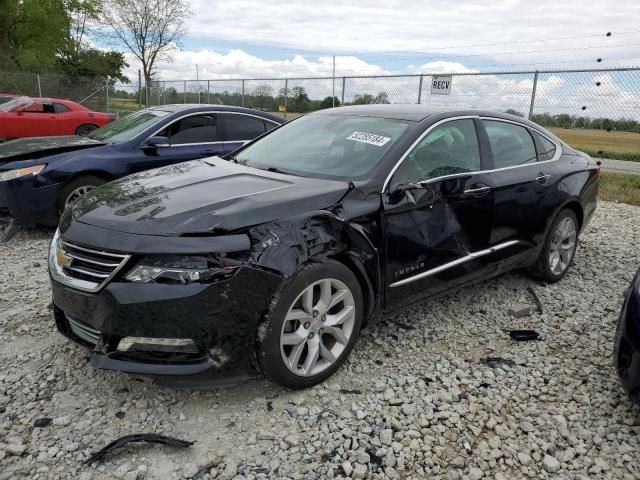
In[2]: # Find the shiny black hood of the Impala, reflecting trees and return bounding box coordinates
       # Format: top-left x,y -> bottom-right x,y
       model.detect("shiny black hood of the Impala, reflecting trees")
72,157 -> 349,236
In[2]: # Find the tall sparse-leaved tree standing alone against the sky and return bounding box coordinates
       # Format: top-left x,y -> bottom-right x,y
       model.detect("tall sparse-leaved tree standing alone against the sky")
100,0 -> 191,85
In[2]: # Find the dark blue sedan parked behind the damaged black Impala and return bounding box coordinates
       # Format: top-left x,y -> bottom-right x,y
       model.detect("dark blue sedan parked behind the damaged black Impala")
0,105 -> 284,230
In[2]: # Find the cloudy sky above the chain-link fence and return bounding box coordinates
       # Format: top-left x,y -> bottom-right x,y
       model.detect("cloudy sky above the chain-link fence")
119,0 -> 640,80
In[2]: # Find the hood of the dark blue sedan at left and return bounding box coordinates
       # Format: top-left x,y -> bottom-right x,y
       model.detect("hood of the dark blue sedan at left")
0,135 -> 104,165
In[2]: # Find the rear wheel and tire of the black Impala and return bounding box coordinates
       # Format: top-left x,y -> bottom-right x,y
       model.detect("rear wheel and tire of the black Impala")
532,208 -> 579,283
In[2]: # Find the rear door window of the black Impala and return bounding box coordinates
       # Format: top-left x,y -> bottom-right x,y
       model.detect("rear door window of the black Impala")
484,120 -> 537,168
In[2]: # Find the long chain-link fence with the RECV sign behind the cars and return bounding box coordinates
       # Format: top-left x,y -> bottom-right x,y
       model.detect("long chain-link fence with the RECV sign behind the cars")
0,68 -> 640,161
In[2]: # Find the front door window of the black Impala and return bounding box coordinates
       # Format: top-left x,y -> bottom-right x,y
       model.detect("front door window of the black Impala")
393,119 -> 480,183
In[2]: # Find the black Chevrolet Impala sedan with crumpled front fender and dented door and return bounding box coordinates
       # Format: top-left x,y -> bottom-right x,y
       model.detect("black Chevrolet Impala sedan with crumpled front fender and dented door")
49,105 -> 599,388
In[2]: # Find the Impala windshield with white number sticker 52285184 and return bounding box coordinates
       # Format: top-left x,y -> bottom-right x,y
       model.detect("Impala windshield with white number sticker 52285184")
232,115 -> 408,179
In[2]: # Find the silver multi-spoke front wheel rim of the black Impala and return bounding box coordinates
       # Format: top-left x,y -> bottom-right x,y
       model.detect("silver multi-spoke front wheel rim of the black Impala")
280,278 -> 356,377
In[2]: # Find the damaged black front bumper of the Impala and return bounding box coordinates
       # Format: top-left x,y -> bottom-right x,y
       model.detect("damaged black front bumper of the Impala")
51,267 -> 281,383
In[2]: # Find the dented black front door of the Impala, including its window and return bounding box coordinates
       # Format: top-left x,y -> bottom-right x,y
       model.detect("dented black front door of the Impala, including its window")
383,118 -> 493,311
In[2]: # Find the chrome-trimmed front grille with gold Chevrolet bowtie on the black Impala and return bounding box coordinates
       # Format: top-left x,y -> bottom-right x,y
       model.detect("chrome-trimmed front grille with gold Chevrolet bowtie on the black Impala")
57,239 -> 129,291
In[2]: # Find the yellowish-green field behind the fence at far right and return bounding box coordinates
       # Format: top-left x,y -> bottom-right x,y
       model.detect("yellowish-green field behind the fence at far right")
549,128 -> 640,162
